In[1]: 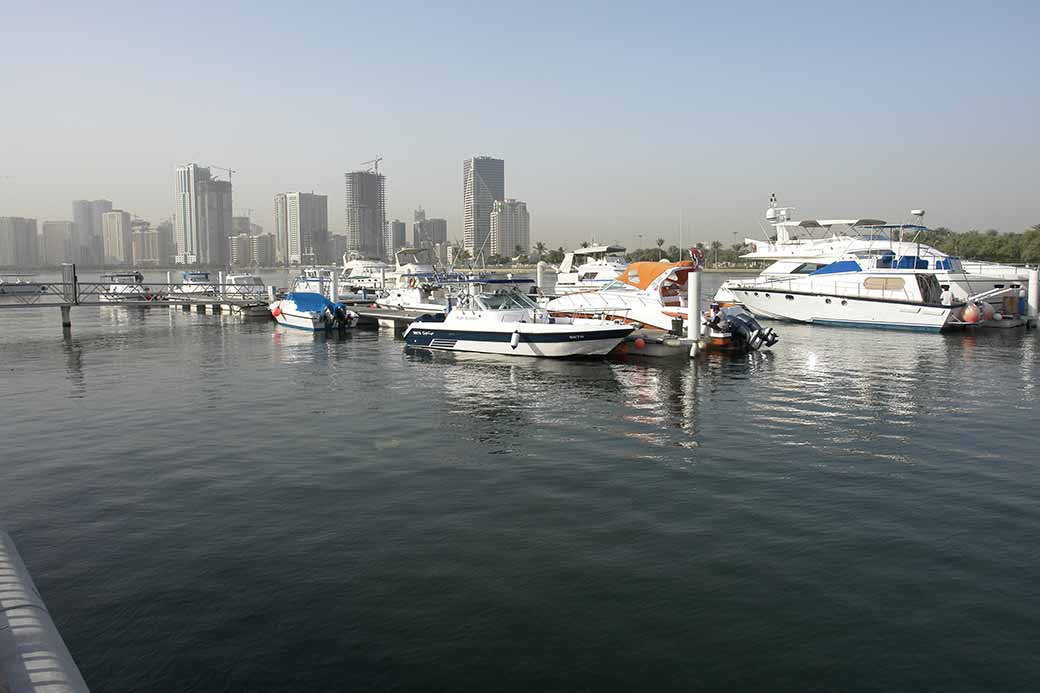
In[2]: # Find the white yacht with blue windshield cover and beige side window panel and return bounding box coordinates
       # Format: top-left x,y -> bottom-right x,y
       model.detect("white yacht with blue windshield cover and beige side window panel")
729,254 -> 952,332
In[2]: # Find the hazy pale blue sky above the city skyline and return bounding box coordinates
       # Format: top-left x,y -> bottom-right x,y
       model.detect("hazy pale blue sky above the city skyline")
0,0 -> 1040,247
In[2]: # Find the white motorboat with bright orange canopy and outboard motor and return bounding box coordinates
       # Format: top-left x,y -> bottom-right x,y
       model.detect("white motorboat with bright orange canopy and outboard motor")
546,260 -> 778,351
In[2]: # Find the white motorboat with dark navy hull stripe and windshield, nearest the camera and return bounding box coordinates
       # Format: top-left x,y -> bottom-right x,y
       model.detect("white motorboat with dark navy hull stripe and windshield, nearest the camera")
405,280 -> 635,358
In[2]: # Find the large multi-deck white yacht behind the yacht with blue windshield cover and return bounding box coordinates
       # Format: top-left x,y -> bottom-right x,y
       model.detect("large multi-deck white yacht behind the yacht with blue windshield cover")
716,196 -> 1029,303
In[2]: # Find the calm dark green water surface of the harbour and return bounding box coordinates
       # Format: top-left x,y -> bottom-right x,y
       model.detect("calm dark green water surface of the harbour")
0,272 -> 1040,691
